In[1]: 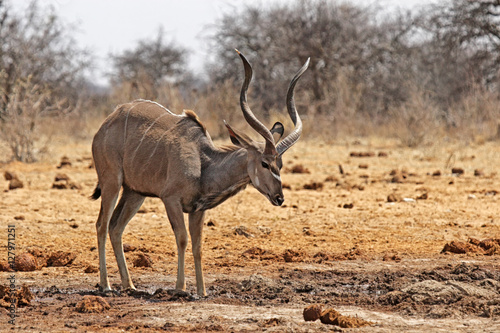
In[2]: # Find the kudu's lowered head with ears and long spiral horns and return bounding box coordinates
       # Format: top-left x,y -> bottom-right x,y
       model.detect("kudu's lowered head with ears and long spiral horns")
224,50 -> 309,206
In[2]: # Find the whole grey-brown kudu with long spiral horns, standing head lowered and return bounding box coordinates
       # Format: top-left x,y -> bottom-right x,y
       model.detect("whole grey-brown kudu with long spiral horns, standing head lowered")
91,50 -> 309,296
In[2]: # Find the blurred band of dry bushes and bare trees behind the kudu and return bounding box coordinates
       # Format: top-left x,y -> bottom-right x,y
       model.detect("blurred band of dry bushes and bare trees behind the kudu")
0,0 -> 500,162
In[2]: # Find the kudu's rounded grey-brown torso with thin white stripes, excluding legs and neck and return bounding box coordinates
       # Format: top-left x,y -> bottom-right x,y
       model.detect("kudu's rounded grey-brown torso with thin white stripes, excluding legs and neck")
92,100 -> 207,197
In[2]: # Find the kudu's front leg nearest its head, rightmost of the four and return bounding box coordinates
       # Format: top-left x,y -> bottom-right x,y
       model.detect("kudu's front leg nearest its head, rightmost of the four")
189,211 -> 207,296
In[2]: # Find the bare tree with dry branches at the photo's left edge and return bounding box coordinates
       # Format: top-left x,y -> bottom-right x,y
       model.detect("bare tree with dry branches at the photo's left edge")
0,1 -> 89,162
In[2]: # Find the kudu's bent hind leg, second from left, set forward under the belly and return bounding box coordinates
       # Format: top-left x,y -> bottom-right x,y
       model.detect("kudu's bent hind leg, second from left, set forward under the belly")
109,186 -> 145,290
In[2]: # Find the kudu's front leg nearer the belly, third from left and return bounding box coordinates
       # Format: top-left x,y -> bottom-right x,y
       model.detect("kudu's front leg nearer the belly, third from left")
163,198 -> 188,290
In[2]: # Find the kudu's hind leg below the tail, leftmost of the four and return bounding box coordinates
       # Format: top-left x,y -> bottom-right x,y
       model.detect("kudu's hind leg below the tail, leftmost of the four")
96,183 -> 121,292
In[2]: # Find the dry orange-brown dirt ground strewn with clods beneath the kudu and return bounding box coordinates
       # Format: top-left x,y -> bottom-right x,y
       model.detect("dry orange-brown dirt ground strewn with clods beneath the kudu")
0,139 -> 500,332
